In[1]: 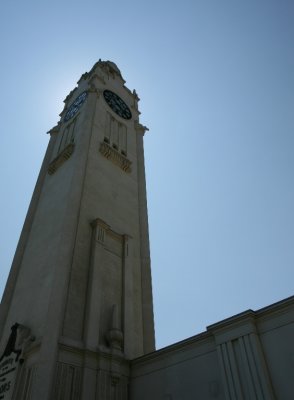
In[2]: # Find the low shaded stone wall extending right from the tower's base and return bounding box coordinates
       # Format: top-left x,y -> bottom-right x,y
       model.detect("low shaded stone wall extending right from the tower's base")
130,297 -> 294,400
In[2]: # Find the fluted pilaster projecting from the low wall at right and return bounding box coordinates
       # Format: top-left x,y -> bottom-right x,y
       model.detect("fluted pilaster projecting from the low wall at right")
208,310 -> 276,400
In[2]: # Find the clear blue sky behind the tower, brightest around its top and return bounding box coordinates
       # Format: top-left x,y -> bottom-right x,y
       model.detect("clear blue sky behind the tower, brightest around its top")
0,0 -> 294,348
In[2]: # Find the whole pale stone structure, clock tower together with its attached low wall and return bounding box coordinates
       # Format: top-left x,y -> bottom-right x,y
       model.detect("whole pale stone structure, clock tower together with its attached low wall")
0,60 -> 294,400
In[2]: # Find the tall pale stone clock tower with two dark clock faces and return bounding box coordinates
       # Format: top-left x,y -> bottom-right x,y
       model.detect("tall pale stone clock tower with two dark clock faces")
0,60 -> 155,400
